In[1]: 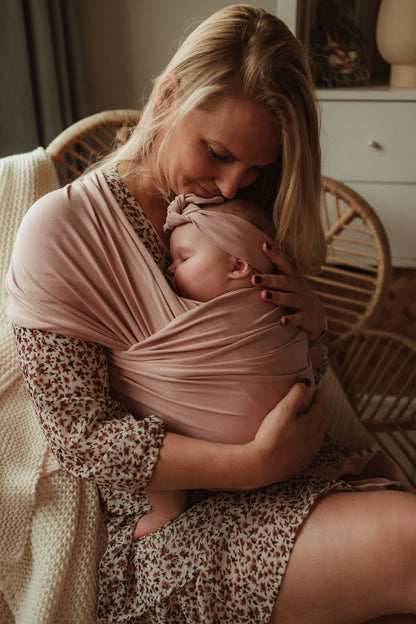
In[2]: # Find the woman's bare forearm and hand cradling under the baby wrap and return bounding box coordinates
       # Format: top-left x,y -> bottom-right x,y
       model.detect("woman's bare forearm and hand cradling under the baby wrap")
149,383 -> 325,490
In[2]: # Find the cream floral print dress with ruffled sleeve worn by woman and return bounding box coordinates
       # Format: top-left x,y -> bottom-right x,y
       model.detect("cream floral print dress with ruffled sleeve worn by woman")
15,171 -> 352,624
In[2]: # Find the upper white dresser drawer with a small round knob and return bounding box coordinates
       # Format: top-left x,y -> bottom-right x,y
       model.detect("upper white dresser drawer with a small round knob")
321,100 -> 416,183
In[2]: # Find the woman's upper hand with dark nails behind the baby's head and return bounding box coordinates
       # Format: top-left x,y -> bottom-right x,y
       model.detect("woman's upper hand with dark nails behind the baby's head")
252,245 -> 325,340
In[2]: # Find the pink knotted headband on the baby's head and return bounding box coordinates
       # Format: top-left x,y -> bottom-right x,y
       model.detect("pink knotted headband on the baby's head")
163,194 -> 274,273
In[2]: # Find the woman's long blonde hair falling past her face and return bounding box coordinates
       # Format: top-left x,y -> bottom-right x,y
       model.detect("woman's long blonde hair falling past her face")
96,5 -> 326,274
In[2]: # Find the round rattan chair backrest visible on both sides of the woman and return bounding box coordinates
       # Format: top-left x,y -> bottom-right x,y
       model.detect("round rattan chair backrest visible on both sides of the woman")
47,110 -> 391,339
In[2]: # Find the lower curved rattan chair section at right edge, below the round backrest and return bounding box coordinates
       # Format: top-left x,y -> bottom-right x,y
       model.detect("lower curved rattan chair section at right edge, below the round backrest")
333,329 -> 416,484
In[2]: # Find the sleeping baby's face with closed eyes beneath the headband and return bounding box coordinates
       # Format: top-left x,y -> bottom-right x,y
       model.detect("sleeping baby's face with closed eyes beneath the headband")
167,223 -> 233,301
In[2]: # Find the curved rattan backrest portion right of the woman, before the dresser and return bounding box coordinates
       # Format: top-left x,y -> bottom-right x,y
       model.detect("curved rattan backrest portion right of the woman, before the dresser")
310,177 -> 391,339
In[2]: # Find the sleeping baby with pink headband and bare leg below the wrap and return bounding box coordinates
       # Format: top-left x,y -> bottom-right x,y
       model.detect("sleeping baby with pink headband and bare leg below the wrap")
133,195 -> 314,539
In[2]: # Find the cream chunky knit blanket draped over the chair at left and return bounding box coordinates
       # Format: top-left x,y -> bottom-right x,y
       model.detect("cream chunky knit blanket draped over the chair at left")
0,147 -> 103,624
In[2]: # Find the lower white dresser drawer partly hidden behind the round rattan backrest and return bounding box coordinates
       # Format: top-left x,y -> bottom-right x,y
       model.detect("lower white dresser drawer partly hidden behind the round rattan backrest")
346,182 -> 416,268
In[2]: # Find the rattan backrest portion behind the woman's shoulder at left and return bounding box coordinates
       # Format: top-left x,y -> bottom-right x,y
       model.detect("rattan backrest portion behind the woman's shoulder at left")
46,110 -> 140,185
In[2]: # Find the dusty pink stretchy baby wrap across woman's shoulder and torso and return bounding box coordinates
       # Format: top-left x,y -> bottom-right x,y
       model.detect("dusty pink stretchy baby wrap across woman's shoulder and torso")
7,172 -> 313,443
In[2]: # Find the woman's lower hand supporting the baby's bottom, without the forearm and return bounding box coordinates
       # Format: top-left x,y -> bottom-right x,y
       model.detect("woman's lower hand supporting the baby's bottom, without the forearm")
248,383 -> 325,487
